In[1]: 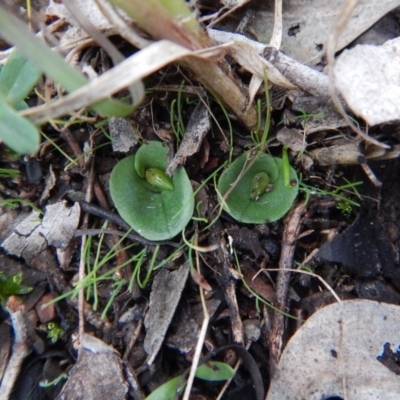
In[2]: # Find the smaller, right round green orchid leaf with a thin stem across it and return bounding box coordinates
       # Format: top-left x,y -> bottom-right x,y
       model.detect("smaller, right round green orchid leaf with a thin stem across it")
217,153 -> 299,224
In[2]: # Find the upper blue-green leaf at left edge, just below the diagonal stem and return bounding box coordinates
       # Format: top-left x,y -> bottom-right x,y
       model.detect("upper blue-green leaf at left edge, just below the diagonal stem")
0,49 -> 42,107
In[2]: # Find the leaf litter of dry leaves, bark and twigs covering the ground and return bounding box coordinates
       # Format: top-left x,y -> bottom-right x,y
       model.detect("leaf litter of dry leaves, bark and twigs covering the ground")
0,0 -> 400,400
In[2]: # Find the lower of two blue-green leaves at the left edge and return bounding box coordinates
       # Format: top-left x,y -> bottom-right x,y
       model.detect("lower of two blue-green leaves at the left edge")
0,97 -> 40,154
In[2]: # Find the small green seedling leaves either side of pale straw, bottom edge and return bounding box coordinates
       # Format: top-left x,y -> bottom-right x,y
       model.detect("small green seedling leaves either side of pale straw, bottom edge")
146,361 -> 235,400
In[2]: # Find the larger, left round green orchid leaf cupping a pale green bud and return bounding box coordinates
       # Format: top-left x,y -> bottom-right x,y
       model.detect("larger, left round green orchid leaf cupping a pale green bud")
110,142 -> 194,240
